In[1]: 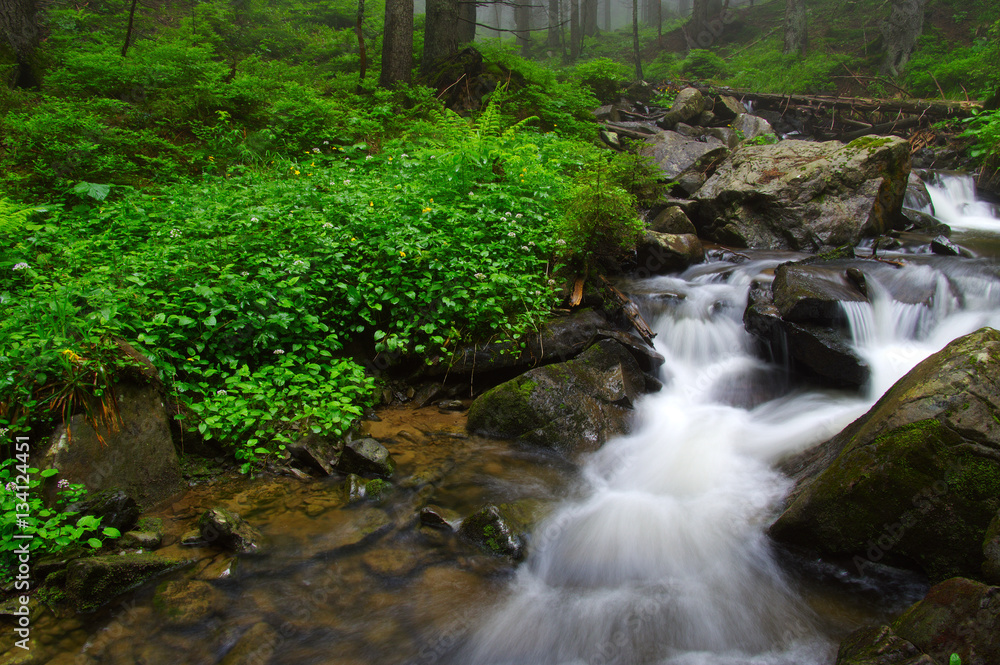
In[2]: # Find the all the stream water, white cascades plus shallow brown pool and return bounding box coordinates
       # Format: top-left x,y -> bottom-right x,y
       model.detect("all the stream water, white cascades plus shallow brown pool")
13,174 -> 1000,665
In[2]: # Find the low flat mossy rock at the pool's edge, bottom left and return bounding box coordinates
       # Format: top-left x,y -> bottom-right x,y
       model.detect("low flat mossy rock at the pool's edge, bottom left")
66,554 -> 187,612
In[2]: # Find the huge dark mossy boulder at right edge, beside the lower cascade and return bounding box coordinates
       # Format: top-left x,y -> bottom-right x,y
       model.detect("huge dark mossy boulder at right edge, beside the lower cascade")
770,328 -> 1000,580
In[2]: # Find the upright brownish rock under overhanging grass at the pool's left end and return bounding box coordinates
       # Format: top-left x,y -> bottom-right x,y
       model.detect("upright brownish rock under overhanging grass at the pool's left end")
38,381 -> 182,506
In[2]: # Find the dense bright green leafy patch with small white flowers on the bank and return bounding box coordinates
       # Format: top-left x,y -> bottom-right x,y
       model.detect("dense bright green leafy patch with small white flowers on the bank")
0,104 -> 628,470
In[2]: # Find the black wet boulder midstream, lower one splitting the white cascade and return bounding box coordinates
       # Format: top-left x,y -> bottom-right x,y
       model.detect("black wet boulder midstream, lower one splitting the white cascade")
743,285 -> 871,388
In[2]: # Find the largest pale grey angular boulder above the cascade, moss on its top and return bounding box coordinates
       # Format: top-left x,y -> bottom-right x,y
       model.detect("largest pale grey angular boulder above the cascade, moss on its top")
692,137 -> 910,250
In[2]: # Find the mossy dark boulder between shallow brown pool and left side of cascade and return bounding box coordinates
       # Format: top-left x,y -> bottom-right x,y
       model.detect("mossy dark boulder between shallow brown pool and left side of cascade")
467,340 -> 646,454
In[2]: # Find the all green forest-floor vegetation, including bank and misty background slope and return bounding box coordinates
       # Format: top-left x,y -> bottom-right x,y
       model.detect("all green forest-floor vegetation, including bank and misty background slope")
0,0 -> 1000,564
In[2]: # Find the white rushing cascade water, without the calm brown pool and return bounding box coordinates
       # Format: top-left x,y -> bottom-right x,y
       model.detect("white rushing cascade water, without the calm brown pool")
458,172 -> 1000,665
